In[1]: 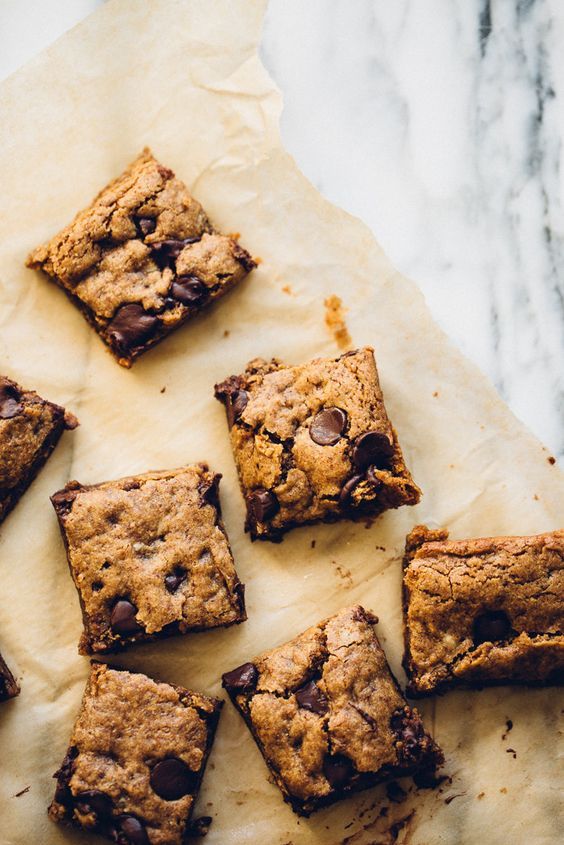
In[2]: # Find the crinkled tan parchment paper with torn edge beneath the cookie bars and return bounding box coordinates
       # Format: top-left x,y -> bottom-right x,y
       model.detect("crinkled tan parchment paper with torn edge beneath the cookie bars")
0,0 -> 564,845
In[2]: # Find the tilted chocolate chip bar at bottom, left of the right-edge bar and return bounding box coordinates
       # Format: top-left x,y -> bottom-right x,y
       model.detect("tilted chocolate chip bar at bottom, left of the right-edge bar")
223,606 -> 443,816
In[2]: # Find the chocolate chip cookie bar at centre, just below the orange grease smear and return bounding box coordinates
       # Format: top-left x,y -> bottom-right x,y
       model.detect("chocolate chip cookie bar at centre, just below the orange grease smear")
215,347 -> 421,540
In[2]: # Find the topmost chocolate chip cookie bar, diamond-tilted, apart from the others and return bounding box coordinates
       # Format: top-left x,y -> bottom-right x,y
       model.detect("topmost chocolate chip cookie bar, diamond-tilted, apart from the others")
27,149 -> 256,367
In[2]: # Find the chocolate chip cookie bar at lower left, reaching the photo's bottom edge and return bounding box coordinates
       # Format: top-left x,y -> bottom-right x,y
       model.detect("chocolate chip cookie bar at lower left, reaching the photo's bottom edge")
49,663 -> 222,845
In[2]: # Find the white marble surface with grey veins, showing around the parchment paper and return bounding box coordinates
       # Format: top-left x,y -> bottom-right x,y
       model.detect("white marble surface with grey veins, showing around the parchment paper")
0,0 -> 564,457
